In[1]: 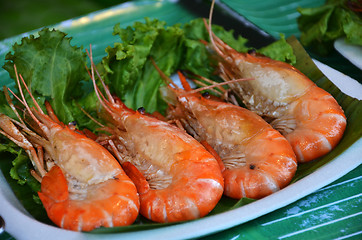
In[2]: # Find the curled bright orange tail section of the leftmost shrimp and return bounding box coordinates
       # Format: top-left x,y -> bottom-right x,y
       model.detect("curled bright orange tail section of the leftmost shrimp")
38,166 -> 139,231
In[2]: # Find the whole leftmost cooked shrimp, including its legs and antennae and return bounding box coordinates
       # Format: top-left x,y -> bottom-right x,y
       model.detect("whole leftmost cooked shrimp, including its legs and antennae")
0,65 -> 139,231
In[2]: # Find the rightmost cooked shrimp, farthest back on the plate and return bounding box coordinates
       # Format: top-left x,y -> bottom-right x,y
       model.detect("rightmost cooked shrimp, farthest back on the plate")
205,0 -> 346,162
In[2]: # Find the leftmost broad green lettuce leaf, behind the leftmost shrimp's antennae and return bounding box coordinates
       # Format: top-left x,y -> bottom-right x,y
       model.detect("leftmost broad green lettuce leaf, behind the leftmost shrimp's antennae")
3,28 -> 88,123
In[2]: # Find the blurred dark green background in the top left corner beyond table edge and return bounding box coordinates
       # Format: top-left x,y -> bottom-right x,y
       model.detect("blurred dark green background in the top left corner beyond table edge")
0,0 -> 121,40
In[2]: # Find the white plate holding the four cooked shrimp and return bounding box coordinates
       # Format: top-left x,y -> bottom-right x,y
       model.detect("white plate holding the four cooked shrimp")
0,61 -> 362,240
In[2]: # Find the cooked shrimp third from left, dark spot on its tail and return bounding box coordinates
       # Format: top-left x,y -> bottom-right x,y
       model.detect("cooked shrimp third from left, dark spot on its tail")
155,62 -> 297,199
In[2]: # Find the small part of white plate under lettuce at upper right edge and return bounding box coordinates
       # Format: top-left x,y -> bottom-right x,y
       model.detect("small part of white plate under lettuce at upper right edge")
334,38 -> 362,69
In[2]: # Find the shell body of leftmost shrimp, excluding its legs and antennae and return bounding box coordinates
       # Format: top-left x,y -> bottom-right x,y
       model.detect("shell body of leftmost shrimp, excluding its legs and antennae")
38,124 -> 139,231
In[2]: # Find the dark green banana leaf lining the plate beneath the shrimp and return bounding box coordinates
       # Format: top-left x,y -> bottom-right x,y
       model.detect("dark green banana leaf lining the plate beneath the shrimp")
0,25 -> 362,236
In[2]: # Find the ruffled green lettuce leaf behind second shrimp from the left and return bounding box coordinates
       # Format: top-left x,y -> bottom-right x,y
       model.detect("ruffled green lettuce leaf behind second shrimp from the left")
102,18 -> 183,112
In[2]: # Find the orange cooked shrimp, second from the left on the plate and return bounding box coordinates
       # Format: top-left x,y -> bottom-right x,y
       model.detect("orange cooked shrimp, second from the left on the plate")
90,48 -> 224,222
